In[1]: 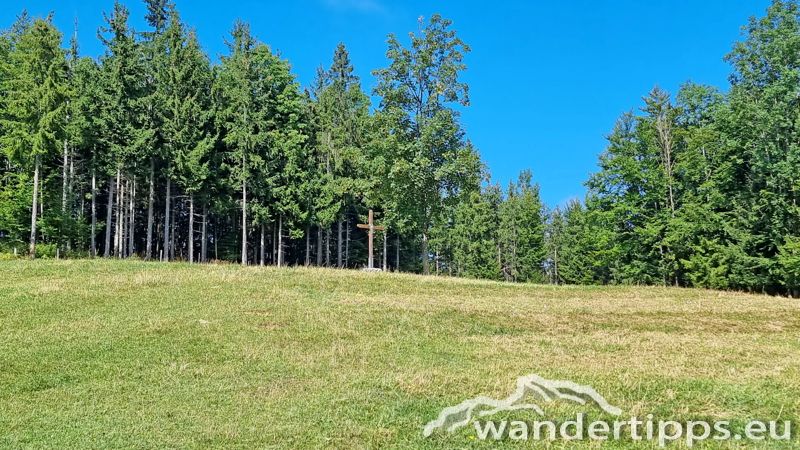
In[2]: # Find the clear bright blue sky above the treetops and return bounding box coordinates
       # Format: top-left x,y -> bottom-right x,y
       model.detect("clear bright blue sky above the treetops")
0,0 -> 770,206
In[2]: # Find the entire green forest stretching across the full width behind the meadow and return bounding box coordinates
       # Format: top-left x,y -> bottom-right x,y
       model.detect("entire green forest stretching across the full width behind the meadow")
0,0 -> 800,296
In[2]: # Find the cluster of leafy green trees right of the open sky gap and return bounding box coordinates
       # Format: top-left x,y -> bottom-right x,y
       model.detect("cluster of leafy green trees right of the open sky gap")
549,0 -> 800,296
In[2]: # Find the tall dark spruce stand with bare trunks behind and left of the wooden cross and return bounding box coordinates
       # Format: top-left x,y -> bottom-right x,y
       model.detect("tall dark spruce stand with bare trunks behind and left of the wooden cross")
0,0 -> 542,279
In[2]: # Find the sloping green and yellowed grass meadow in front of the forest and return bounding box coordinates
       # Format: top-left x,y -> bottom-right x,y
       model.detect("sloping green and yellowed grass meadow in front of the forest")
0,260 -> 800,449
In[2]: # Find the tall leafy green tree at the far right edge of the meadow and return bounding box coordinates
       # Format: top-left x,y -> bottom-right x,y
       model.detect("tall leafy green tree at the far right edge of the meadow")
719,0 -> 800,292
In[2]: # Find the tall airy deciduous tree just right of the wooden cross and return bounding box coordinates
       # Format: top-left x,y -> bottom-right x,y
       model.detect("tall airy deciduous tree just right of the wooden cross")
373,14 -> 482,273
